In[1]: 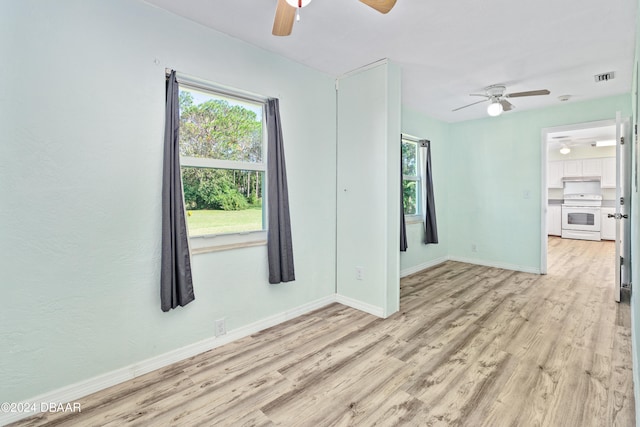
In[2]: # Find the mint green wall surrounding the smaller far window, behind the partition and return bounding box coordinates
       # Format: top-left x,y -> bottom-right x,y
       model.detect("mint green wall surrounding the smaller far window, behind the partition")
400,107 -> 450,272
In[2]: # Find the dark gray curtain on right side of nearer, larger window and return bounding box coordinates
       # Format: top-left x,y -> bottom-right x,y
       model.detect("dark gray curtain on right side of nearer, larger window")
267,99 -> 296,283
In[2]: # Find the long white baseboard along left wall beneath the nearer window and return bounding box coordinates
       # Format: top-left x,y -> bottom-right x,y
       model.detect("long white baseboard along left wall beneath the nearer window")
0,294 -> 338,426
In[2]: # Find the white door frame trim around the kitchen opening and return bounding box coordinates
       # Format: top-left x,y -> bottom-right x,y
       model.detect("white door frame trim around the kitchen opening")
540,117 -> 631,274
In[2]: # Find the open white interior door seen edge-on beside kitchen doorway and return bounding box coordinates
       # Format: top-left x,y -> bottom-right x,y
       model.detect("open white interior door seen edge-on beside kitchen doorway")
614,112 -> 631,302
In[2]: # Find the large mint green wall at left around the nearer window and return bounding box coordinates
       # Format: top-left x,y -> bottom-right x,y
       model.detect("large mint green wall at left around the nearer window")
0,0 -> 336,402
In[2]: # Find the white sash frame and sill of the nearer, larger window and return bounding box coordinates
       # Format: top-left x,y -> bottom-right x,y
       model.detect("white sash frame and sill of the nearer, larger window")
177,74 -> 268,255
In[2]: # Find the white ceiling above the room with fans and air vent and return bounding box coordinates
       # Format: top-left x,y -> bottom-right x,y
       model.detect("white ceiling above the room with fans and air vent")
145,0 -> 637,122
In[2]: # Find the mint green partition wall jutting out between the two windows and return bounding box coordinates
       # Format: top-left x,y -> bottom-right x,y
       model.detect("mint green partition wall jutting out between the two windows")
337,63 -> 401,316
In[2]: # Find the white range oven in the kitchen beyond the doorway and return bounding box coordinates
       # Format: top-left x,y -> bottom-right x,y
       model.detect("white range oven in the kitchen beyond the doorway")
562,194 -> 602,240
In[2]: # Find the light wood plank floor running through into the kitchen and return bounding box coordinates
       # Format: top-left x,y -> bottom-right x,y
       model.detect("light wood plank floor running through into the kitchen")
16,238 -> 635,427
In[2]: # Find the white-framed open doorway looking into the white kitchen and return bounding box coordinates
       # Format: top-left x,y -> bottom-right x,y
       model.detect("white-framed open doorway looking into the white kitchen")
540,116 -> 631,301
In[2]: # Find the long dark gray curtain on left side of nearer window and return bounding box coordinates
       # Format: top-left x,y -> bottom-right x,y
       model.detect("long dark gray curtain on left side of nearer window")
160,71 -> 194,311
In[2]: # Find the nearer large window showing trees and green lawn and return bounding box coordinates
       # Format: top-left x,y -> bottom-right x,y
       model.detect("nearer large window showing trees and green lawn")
179,86 -> 266,241
